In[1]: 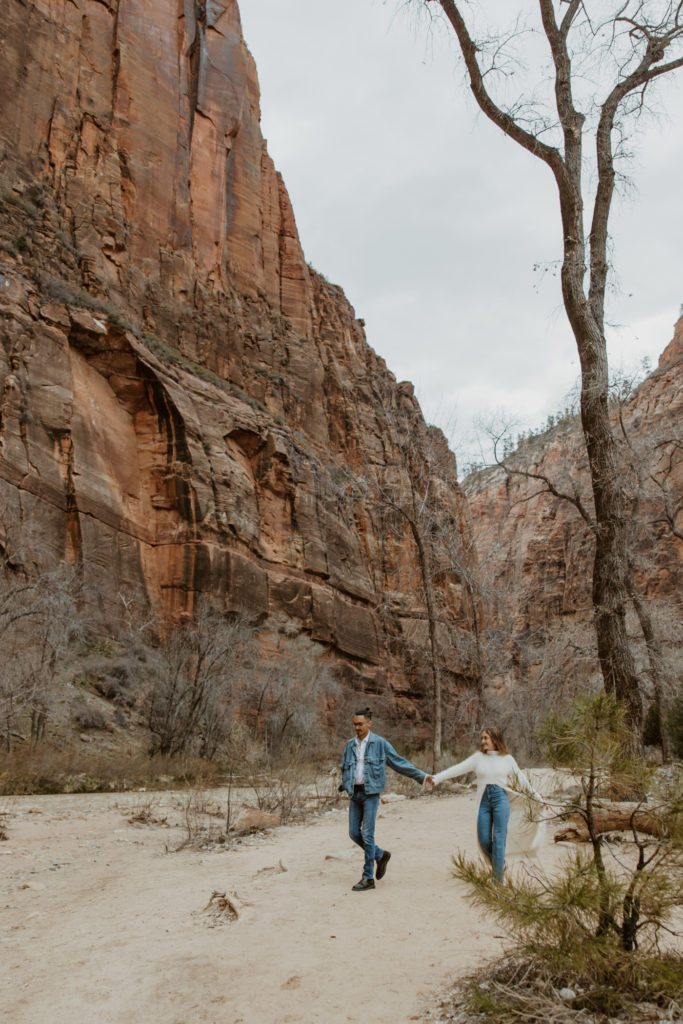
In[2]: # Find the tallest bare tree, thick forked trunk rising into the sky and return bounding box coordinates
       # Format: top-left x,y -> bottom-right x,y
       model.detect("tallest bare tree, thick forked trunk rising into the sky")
409,0 -> 683,734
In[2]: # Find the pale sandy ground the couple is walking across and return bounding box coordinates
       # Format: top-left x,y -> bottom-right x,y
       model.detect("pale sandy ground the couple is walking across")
0,790 -> 558,1024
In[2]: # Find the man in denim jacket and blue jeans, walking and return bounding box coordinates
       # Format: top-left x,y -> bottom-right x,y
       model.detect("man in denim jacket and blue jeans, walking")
339,708 -> 431,892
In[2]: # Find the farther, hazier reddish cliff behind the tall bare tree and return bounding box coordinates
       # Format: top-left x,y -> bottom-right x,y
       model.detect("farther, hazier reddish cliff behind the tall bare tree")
463,319 -> 683,708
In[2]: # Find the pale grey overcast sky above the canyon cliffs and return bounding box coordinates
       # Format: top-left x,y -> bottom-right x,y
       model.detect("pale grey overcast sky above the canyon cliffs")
240,0 -> 683,464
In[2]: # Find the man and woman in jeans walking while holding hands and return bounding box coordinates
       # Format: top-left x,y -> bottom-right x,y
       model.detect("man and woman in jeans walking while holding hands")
340,708 -> 547,892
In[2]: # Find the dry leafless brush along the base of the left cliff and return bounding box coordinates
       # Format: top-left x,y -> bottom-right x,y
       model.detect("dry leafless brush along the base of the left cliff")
0,548 -> 345,793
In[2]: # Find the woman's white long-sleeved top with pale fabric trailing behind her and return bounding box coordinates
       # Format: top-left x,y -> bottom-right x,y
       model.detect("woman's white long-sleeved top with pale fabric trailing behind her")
434,751 -> 546,857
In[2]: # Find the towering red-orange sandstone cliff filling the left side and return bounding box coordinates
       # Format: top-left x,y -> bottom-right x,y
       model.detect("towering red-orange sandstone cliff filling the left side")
0,0 -> 473,729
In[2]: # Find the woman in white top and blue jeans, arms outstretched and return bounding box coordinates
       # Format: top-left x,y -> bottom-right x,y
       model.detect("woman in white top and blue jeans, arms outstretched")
427,729 -> 547,883
